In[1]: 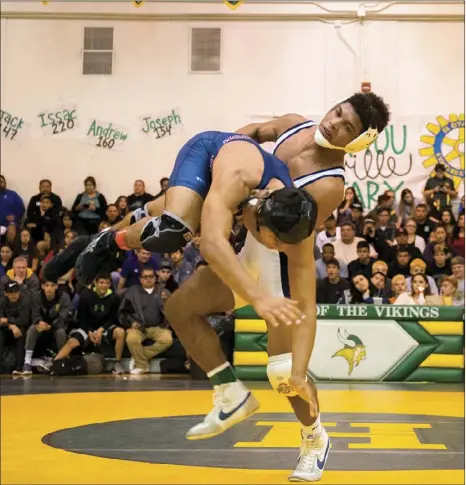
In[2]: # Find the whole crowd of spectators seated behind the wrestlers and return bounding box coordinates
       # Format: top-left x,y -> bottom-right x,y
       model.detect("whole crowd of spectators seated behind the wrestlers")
0,164 -> 464,376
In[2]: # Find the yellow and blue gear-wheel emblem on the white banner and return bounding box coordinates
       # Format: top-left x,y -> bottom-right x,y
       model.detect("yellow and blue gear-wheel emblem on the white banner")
419,113 -> 464,188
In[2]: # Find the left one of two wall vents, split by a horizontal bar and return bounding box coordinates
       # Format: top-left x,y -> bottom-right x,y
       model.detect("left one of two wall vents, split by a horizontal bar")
83,27 -> 113,75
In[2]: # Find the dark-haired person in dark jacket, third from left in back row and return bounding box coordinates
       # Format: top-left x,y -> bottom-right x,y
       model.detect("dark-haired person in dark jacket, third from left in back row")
72,177 -> 107,234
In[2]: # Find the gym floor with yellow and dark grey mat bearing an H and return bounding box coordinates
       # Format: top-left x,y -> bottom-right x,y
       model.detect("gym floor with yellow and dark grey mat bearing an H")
0,375 -> 465,485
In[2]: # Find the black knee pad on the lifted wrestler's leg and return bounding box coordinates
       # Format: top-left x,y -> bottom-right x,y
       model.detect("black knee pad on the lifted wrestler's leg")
140,214 -> 193,253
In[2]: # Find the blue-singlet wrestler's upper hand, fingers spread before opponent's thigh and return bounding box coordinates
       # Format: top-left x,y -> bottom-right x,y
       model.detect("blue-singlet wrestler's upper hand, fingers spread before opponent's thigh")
253,296 -> 305,327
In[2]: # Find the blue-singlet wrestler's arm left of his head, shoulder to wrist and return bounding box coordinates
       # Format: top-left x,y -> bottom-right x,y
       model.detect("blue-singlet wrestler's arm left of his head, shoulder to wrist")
201,163 -> 270,304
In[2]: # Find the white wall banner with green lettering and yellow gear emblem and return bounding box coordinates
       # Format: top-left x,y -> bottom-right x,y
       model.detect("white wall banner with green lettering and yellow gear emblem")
345,114 -> 464,209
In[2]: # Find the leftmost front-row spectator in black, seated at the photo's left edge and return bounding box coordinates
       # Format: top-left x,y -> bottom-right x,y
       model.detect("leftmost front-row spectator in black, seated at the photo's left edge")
0,281 -> 32,374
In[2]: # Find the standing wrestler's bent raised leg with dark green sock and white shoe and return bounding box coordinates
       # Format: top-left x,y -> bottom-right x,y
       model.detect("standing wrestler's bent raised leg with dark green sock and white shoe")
164,267 -> 259,440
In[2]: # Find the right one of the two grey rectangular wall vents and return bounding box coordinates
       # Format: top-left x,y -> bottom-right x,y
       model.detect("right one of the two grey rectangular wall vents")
191,28 -> 222,72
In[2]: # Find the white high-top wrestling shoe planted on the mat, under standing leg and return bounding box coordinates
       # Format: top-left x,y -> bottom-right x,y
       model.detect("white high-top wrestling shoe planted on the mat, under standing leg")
288,429 -> 330,482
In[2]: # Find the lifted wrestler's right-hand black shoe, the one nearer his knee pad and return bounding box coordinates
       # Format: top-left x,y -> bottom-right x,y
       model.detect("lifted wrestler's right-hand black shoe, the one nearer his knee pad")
75,230 -> 118,286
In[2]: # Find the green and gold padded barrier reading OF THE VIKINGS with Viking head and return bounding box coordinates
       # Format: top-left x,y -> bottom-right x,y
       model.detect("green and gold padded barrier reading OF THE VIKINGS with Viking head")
234,305 -> 464,382
